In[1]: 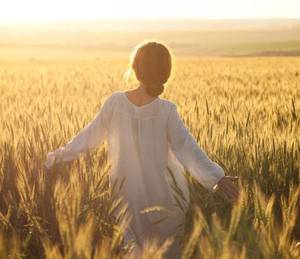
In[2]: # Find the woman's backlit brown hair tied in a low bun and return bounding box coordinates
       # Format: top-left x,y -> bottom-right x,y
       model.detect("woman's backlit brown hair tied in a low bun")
125,40 -> 172,96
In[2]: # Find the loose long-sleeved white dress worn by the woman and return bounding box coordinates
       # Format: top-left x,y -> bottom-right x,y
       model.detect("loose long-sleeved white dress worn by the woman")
45,91 -> 224,258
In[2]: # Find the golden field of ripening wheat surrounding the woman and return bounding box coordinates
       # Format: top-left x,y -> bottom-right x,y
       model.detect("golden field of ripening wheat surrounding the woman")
0,57 -> 300,259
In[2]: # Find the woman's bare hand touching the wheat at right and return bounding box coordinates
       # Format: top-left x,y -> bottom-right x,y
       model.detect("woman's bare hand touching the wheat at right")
214,176 -> 239,203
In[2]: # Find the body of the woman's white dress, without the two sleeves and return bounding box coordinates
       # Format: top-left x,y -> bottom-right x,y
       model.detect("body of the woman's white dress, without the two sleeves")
107,92 -> 189,258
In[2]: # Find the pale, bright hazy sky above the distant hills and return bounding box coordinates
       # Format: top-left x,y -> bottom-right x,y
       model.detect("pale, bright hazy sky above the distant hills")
0,0 -> 300,21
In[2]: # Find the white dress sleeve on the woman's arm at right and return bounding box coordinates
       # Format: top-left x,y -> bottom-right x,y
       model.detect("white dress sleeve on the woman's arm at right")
167,104 -> 225,189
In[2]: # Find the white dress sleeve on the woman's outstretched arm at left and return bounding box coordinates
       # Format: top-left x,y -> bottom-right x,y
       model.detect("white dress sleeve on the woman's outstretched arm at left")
45,93 -> 113,168
